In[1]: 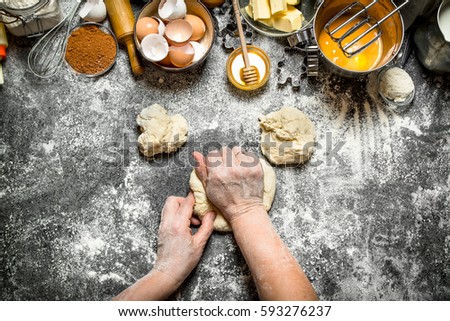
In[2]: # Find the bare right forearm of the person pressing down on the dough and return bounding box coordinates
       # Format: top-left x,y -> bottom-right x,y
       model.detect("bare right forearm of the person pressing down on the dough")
232,207 -> 317,301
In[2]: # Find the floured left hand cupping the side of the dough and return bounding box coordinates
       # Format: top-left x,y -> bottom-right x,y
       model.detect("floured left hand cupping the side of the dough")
154,193 -> 215,287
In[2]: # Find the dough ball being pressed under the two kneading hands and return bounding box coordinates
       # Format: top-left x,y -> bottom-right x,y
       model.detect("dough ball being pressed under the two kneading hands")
189,159 -> 276,232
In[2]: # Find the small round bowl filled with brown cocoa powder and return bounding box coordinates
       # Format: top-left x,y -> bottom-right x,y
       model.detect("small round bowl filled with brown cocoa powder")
65,22 -> 119,77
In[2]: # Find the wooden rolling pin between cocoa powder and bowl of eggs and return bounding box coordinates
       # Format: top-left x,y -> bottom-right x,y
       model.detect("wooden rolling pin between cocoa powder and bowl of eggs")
105,0 -> 144,76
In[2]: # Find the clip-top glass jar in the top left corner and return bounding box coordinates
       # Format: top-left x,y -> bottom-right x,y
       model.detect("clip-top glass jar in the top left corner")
0,0 -> 62,37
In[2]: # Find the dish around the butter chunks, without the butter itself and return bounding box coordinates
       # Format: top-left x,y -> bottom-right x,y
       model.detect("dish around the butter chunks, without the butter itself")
238,0 -> 316,38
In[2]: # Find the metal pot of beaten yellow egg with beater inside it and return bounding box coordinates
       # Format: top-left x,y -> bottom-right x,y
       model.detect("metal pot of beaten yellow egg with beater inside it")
313,0 -> 408,77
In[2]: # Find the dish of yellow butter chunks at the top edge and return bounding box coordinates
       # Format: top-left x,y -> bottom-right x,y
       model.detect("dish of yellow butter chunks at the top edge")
238,0 -> 316,37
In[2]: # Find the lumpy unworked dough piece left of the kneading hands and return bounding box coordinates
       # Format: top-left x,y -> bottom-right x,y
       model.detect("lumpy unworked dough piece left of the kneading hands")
136,104 -> 188,158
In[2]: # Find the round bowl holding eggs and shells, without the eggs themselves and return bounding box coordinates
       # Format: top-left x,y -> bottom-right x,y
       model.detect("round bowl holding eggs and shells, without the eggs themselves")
134,0 -> 216,72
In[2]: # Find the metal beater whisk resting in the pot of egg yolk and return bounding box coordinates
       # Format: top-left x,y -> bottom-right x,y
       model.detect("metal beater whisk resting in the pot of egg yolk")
324,0 -> 409,57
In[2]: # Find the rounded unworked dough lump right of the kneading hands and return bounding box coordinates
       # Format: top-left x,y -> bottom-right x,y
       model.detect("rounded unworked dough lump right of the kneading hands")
259,107 -> 316,165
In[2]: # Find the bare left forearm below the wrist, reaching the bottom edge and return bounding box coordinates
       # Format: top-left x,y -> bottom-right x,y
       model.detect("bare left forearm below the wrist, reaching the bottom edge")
113,270 -> 179,301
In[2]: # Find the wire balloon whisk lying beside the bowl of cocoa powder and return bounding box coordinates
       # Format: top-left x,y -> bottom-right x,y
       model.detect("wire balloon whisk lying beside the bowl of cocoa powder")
28,0 -> 81,78
